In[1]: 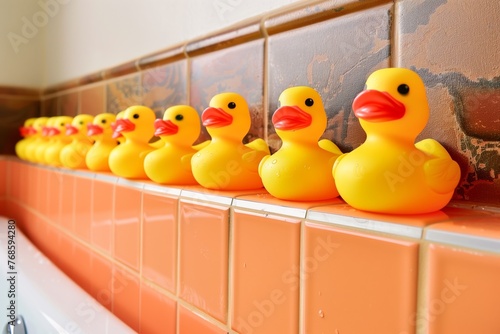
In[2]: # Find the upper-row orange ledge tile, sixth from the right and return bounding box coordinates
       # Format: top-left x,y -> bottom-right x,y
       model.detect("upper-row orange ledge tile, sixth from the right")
113,185 -> 142,270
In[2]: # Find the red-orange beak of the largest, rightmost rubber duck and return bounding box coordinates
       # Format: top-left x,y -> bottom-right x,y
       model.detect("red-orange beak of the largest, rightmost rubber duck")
352,90 -> 406,122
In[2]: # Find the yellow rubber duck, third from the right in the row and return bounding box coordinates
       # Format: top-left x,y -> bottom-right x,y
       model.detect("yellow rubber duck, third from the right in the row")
191,93 -> 270,190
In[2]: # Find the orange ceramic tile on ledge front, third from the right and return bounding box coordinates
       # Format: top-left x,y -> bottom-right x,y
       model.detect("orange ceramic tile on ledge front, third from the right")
231,209 -> 300,334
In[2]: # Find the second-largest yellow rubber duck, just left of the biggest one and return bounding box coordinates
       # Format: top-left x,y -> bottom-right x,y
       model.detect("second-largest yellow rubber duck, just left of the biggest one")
259,86 -> 342,201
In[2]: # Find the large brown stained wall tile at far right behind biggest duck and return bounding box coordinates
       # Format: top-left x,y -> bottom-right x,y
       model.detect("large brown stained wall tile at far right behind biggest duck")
394,0 -> 500,205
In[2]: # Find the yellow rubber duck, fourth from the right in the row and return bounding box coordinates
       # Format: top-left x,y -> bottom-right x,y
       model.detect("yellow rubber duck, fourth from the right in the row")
144,105 -> 208,185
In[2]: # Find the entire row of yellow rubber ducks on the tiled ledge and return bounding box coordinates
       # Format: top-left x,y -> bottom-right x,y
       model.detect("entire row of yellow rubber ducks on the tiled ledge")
16,68 -> 460,214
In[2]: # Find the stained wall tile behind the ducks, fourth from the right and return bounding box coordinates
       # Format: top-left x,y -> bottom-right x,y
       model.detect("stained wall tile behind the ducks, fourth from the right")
142,60 -> 188,118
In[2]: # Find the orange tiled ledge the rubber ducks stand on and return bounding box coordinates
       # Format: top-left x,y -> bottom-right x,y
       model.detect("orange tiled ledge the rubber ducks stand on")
0,157 -> 500,334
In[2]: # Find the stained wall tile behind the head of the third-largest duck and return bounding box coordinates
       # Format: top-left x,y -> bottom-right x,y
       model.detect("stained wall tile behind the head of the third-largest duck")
190,39 -> 265,142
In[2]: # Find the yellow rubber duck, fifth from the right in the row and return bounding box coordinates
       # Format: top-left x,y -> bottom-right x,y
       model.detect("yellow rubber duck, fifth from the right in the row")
109,106 -> 156,179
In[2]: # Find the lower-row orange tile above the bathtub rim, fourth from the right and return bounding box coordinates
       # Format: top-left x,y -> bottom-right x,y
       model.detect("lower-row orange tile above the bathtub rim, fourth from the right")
88,252 -> 113,310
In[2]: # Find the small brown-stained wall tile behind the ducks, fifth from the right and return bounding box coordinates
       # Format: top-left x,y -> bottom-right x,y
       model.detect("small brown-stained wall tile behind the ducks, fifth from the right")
106,73 -> 142,114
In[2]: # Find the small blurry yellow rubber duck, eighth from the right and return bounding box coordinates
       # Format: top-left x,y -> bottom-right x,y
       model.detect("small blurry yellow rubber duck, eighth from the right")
43,116 -> 73,167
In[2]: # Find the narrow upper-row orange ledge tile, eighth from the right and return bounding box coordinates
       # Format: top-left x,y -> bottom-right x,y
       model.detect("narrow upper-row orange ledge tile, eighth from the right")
74,176 -> 92,243
